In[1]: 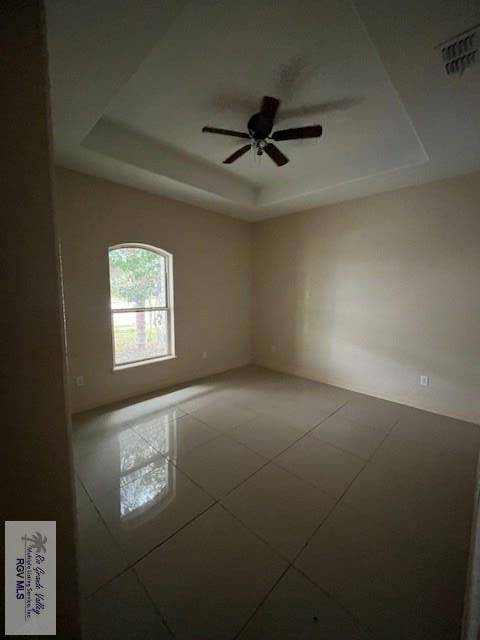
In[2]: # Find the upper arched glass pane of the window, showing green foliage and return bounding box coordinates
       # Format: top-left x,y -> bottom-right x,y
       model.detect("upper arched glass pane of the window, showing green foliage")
109,247 -> 167,309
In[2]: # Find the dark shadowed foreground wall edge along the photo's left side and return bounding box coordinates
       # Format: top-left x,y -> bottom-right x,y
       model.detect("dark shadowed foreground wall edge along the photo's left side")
4,0 -> 80,640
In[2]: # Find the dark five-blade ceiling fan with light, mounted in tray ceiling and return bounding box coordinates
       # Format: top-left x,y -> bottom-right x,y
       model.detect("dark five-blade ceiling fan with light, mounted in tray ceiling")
202,96 -> 322,167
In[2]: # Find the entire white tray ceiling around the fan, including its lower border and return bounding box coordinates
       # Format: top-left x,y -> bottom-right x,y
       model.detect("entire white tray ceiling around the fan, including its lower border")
47,0 -> 480,220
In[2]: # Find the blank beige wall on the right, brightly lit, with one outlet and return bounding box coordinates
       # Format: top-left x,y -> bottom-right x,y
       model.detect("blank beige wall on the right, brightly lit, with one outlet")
253,173 -> 480,422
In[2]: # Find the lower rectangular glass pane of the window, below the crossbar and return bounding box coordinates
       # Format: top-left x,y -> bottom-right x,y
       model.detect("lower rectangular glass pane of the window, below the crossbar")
113,310 -> 169,364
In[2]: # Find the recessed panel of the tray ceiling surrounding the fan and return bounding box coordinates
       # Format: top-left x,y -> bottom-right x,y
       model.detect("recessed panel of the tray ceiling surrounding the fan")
101,0 -> 427,204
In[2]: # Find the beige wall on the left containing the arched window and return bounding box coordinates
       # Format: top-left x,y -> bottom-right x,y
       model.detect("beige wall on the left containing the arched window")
57,169 -> 252,411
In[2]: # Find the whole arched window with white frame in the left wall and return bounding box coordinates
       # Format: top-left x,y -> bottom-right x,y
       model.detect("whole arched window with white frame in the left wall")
108,244 -> 175,367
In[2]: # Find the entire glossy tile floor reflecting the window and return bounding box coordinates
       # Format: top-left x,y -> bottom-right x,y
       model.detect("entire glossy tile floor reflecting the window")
74,367 -> 480,640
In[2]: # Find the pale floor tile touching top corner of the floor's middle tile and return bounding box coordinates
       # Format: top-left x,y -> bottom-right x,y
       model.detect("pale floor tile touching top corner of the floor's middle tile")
228,415 -> 302,459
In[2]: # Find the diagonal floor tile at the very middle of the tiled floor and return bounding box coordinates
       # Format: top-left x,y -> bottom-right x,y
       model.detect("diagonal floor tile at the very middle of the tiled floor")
222,465 -> 335,560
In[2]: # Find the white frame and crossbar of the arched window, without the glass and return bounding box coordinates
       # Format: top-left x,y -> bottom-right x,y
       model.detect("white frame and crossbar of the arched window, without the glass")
107,242 -> 177,372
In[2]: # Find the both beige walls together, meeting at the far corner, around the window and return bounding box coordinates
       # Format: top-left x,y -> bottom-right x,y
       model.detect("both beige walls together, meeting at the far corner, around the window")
57,169 -> 480,422
